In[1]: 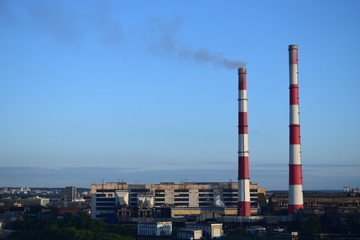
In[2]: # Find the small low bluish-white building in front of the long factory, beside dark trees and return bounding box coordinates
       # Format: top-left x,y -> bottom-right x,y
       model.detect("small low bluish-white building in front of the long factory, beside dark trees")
137,222 -> 172,237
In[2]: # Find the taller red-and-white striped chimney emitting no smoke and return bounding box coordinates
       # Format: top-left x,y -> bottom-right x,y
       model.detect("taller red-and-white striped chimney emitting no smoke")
289,45 -> 304,214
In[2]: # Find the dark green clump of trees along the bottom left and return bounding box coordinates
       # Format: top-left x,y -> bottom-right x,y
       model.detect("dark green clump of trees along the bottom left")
8,213 -> 136,240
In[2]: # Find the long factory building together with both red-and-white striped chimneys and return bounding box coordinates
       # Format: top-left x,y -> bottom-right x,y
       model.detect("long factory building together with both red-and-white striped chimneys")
91,45 -> 304,223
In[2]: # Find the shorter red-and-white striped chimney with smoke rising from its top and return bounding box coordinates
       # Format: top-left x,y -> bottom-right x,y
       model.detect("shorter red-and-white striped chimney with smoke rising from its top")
237,68 -> 251,216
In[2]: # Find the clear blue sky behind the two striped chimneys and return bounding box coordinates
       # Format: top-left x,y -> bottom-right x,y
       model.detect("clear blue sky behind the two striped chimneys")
0,0 -> 360,190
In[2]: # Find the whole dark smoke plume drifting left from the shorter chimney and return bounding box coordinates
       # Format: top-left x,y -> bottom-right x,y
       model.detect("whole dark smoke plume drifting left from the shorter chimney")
0,0 -> 245,69
